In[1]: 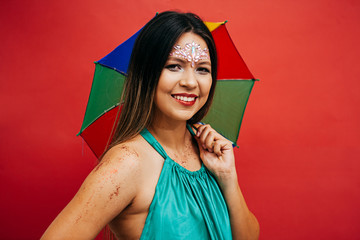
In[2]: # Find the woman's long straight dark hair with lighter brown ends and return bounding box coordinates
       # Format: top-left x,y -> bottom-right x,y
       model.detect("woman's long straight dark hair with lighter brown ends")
109,11 -> 217,148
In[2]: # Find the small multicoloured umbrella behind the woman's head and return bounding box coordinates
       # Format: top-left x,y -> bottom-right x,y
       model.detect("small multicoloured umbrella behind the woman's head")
78,21 -> 256,157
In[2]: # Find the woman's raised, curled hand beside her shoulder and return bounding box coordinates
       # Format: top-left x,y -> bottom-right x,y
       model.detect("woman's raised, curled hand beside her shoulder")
194,124 -> 237,187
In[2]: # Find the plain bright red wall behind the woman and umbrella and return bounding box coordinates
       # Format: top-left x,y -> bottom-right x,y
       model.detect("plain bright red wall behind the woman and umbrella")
0,0 -> 360,240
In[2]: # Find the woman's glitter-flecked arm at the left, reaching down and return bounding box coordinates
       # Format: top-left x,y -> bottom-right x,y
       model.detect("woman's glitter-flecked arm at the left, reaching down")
41,144 -> 140,240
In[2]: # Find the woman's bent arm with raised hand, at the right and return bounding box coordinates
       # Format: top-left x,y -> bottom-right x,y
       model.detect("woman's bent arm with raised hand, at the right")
195,124 -> 259,240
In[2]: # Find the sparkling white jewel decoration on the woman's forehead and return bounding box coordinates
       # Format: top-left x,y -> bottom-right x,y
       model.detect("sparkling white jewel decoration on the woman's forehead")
170,42 -> 209,67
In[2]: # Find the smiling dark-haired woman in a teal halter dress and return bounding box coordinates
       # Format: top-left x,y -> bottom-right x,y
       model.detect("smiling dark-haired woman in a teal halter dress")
42,12 -> 259,239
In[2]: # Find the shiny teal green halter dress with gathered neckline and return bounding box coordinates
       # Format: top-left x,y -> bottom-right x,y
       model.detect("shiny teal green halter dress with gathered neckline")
140,126 -> 232,240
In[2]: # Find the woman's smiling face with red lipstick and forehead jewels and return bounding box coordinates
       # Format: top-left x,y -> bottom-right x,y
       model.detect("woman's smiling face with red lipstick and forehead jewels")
155,32 -> 212,124
